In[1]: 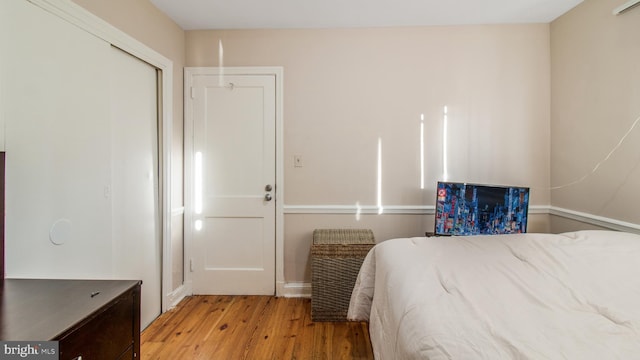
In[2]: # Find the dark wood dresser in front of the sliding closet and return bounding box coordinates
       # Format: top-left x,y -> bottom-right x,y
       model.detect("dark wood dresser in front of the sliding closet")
0,279 -> 141,360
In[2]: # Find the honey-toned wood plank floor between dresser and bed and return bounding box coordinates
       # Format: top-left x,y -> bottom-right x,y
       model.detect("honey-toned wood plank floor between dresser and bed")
140,296 -> 373,360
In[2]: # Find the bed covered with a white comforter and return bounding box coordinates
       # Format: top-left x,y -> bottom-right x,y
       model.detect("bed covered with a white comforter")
347,231 -> 640,360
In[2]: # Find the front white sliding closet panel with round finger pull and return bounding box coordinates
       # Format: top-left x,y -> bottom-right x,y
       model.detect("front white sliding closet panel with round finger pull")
0,1 -> 112,278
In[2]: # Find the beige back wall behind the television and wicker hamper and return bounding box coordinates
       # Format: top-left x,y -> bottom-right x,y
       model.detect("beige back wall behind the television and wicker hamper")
185,24 -> 550,282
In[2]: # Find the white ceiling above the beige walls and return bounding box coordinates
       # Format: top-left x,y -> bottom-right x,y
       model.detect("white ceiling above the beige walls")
150,0 -> 582,30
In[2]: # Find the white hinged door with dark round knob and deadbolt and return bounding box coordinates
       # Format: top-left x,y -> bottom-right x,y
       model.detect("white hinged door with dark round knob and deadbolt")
187,74 -> 276,295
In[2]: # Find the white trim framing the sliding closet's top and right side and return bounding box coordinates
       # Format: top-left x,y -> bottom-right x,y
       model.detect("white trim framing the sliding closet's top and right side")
28,0 -> 176,312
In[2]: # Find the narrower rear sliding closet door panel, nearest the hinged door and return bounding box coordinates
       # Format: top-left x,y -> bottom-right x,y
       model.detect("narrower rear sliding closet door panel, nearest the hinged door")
110,48 -> 162,328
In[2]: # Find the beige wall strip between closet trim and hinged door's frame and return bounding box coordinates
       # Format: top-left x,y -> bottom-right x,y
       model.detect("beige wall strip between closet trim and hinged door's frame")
73,0 -> 185,288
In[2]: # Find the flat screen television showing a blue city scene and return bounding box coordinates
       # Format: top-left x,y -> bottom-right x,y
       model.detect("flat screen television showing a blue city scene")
435,181 -> 529,235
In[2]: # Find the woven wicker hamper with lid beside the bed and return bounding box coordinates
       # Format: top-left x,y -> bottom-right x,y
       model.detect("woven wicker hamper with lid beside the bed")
311,229 -> 375,321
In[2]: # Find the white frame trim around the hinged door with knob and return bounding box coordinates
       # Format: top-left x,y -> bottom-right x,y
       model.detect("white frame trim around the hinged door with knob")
184,66 -> 285,296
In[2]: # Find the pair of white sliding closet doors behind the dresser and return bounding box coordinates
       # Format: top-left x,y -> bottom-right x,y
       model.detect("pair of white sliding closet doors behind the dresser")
0,0 -> 162,326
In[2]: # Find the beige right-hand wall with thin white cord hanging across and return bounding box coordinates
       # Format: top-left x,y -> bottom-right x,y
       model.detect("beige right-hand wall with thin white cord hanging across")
551,0 -> 640,231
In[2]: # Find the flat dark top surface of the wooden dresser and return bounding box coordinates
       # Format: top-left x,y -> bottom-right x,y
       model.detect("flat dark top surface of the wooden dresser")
0,279 -> 141,341
